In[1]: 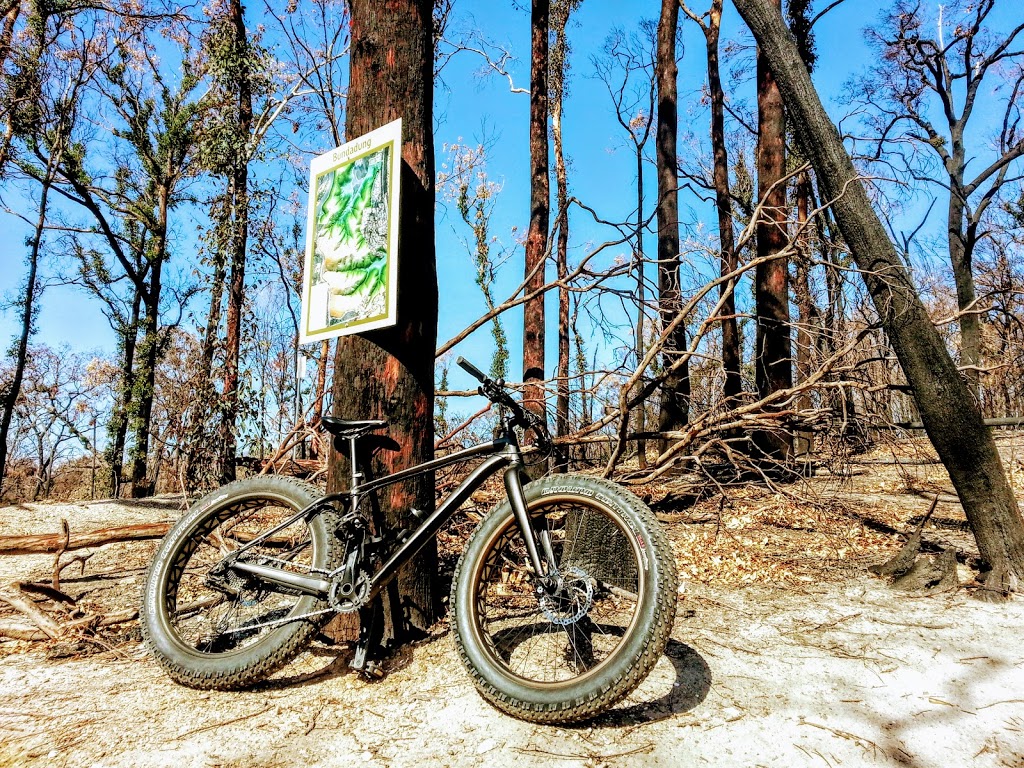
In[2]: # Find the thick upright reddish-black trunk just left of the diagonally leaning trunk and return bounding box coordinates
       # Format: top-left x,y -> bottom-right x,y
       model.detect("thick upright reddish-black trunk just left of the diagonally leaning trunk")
754,0 -> 793,461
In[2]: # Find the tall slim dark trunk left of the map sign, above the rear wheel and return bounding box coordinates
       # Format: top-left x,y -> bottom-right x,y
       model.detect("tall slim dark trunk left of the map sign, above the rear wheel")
220,0 -> 253,483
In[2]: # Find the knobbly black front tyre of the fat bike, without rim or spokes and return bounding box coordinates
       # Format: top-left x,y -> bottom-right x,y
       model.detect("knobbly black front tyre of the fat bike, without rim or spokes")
452,475 -> 677,724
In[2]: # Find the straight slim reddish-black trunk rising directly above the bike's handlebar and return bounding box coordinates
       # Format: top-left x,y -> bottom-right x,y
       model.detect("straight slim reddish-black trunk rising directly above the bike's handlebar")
522,0 -> 550,450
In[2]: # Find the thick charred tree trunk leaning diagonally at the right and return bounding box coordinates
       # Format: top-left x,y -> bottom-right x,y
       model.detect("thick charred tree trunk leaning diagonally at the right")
733,0 -> 1024,596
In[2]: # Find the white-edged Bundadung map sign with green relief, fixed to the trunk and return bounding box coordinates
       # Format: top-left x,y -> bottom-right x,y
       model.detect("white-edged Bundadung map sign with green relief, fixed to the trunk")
300,120 -> 401,343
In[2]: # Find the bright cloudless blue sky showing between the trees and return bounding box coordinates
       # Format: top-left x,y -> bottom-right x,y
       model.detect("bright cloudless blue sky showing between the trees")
0,0 -> 909,378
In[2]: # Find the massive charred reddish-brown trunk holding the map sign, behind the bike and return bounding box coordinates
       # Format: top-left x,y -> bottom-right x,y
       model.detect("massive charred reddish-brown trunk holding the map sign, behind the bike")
328,0 -> 440,640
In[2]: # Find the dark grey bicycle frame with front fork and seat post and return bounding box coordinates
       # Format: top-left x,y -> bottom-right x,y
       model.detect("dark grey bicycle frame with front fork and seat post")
225,428 -> 554,604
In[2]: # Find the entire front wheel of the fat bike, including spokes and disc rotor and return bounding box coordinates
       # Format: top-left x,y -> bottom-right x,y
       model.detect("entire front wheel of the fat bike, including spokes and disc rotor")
452,475 -> 677,723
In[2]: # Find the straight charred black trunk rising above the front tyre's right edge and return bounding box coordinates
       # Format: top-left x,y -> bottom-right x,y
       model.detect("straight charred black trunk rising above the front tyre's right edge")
654,0 -> 690,451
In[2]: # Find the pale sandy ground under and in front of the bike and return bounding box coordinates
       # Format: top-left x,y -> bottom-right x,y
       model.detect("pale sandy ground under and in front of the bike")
0,481 -> 1024,768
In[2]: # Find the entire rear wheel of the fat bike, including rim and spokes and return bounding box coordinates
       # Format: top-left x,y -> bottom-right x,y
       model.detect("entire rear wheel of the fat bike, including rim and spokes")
140,476 -> 339,690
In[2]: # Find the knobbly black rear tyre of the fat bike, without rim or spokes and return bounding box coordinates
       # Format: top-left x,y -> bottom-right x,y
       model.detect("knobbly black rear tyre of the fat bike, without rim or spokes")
140,475 -> 341,690
